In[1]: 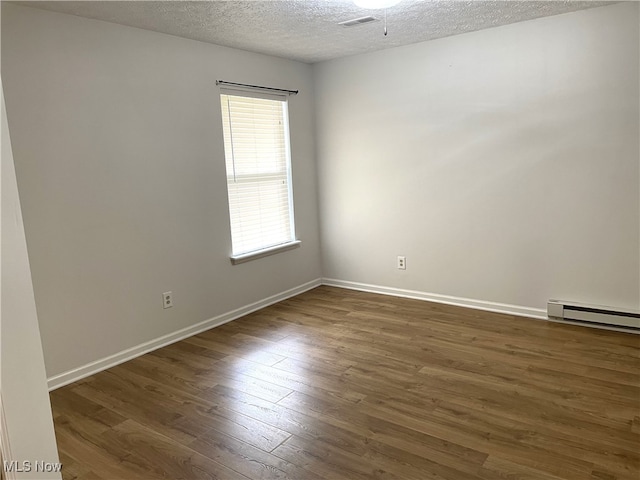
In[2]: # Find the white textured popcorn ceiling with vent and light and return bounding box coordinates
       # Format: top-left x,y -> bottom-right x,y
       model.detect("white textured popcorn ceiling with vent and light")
14,0 -> 616,63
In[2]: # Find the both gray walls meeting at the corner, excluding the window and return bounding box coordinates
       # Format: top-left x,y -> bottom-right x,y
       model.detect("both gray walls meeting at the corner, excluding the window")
2,3 -> 640,377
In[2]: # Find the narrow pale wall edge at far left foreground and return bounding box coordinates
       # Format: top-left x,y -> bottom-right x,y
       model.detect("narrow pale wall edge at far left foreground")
0,80 -> 60,479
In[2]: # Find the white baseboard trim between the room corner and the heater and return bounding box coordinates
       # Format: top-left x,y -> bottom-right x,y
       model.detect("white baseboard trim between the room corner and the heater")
322,278 -> 548,320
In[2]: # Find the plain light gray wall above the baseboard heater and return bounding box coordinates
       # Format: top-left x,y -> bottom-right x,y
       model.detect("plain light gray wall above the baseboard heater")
314,3 -> 640,308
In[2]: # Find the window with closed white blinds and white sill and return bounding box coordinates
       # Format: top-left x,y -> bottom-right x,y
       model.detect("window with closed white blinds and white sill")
220,90 -> 299,263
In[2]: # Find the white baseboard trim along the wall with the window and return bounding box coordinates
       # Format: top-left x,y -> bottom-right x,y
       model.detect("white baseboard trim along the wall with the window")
47,278 -> 322,391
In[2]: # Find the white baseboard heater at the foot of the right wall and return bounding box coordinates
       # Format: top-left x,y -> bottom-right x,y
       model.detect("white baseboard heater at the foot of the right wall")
547,300 -> 640,333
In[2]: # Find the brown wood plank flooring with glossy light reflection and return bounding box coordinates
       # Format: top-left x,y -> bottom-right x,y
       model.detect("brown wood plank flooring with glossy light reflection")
51,287 -> 640,480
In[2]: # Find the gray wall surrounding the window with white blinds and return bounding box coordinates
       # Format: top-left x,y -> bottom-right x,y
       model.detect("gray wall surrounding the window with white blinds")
2,2 -> 321,377
